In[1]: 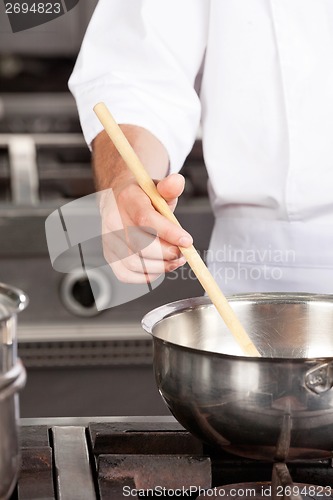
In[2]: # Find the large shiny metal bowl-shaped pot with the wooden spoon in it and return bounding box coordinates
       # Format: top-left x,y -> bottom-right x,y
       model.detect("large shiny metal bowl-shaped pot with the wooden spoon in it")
142,294 -> 333,461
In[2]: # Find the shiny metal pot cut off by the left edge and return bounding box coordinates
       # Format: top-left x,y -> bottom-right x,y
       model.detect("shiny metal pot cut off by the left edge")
0,283 -> 28,500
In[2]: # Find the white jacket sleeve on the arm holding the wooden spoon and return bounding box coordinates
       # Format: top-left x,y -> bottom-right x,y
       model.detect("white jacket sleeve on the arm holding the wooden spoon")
69,0 -> 209,172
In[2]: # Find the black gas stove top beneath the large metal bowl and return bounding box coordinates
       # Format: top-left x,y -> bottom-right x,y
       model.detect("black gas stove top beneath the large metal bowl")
11,417 -> 333,500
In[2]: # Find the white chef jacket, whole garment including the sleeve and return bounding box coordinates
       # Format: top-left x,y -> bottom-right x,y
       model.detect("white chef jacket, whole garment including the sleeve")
69,0 -> 333,293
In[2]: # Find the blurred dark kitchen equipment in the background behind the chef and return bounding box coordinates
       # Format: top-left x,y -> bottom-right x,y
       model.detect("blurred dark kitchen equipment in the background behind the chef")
0,0 -> 213,417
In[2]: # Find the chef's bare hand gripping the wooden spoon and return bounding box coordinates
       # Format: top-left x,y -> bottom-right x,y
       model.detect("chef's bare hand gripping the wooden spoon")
95,127 -> 192,284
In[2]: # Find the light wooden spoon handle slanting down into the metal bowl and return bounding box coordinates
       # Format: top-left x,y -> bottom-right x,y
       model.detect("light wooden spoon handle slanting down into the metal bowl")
94,103 -> 260,356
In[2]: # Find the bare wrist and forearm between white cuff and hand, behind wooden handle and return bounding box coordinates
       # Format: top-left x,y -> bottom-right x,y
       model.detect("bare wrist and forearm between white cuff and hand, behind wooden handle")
92,125 -> 169,190
